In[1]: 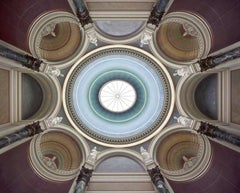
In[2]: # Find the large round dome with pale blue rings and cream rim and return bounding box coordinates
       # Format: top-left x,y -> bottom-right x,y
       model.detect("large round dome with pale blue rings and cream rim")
63,45 -> 174,147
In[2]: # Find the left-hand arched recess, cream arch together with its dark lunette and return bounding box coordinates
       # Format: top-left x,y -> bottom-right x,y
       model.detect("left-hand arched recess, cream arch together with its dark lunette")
19,73 -> 60,121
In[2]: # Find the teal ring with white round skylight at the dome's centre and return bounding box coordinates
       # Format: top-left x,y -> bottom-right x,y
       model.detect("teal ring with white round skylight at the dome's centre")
89,70 -> 147,122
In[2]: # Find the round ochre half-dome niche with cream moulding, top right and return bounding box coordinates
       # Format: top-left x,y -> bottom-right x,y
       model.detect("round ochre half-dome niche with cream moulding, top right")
153,12 -> 212,66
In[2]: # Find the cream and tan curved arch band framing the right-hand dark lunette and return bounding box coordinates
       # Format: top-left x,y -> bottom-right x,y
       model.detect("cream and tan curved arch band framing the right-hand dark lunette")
176,73 -> 218,120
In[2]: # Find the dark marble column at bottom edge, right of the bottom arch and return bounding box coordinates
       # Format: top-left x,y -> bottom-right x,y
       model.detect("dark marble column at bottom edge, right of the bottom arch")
148,166 -> 169,193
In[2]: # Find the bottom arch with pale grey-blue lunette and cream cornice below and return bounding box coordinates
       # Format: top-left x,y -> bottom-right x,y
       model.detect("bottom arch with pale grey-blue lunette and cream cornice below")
88,152 -> 154,192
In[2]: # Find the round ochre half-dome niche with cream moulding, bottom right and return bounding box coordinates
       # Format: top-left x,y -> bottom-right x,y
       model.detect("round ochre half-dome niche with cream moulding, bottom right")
155,128 -> 211,181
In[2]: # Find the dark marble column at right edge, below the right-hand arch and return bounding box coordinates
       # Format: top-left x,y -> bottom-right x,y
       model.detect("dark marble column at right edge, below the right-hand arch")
197,122 -> 240,147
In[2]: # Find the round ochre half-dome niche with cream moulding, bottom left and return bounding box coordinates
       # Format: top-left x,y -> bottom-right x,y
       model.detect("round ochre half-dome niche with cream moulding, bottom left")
29,129 -> 83,181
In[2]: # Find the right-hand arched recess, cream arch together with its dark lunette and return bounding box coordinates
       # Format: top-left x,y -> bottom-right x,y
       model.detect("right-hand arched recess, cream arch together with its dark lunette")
177,73 -> 220,120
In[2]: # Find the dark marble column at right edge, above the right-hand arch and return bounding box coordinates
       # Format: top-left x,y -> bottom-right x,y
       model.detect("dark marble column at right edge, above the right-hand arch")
198,48 -> 240,72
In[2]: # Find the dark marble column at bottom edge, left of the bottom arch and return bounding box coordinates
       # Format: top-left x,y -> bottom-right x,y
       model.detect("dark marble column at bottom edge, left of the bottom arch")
74,166 -> 93,193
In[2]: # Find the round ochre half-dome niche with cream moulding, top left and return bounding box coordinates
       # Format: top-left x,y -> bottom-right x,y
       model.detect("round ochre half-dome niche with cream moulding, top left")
28,11 -> 84,65
